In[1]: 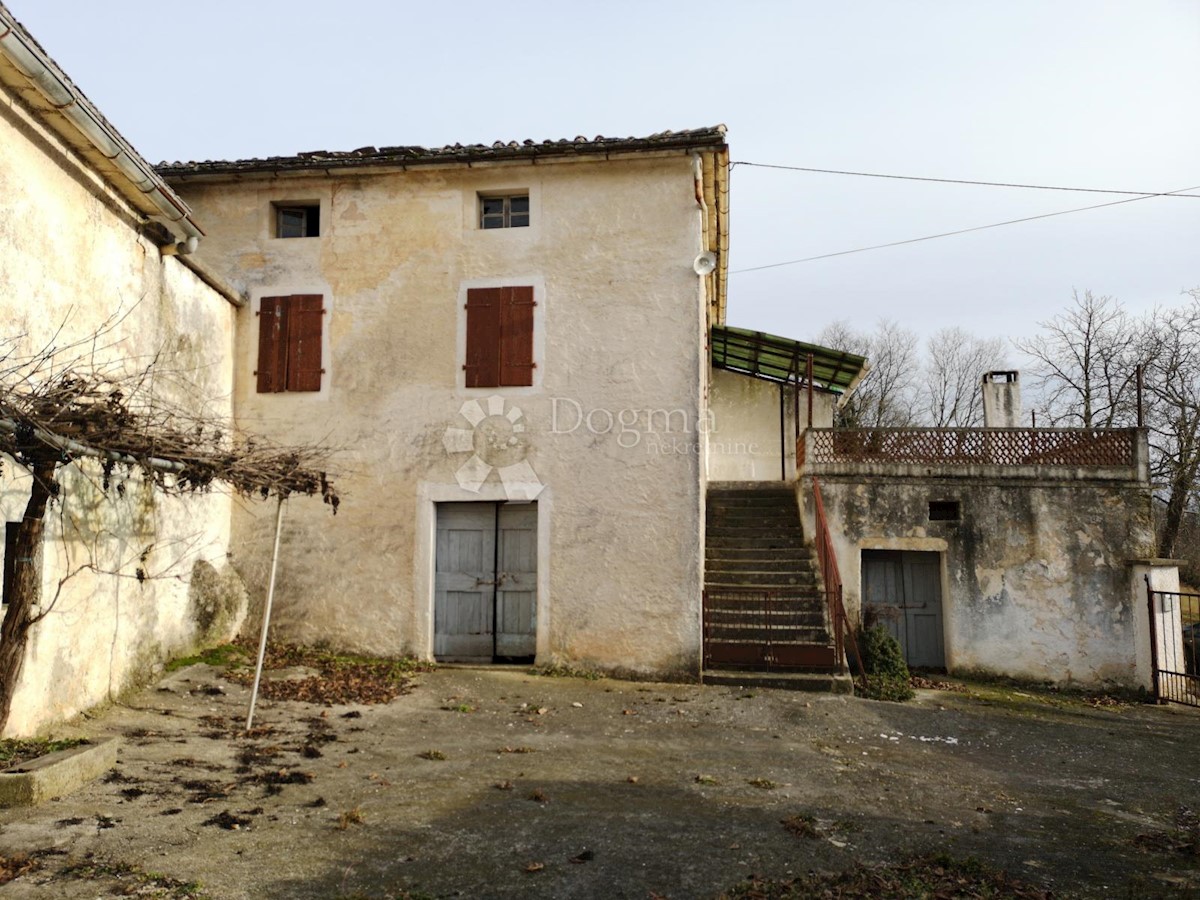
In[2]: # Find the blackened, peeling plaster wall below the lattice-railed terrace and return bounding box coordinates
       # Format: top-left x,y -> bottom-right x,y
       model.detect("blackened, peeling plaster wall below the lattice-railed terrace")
798,448 -> 1153,686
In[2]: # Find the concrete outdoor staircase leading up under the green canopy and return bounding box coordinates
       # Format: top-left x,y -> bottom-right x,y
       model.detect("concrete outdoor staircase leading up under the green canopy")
703,482 -> 851,692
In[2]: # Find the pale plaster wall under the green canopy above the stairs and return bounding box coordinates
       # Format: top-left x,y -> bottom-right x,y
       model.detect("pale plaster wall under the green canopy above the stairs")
708,368 -> 836,481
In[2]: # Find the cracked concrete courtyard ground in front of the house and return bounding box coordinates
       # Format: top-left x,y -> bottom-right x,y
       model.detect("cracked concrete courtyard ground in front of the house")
0,665 -> 1200,900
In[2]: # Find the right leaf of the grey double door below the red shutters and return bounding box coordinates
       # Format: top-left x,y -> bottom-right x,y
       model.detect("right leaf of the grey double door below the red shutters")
496,503 -> 538,659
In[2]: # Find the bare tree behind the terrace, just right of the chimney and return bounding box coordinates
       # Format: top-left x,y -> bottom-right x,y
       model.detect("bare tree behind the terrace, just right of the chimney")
1016,290 -> 1145,428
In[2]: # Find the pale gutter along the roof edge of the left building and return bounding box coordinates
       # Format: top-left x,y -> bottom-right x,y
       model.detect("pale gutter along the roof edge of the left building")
0,6 -> 204,256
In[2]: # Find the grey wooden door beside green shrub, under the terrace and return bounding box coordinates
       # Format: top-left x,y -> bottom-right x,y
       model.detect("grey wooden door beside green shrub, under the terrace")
863,550 -> 946,668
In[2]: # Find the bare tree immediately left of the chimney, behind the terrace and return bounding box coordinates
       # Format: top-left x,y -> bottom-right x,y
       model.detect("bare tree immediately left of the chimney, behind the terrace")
919,328 -> 1006,428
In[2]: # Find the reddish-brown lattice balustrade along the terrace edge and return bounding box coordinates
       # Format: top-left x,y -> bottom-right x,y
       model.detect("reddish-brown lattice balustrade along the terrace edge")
802,428 -> 1138,466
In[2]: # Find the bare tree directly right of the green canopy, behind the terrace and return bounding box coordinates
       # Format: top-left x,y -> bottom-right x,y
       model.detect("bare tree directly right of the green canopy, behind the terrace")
817,319 -> 918,428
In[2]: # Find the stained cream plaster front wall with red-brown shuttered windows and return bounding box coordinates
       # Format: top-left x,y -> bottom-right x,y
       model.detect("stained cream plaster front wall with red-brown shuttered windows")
178,155 -> 706,674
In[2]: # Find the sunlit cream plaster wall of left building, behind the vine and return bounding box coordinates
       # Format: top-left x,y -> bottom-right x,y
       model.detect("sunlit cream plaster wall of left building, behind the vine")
0,82 -> 233,734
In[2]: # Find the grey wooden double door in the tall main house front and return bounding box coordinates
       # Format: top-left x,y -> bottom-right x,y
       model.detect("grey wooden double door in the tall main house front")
433,503 -> 538,662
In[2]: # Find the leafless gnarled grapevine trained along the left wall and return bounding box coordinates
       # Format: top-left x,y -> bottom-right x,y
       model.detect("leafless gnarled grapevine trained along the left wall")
0,331 -> 338,731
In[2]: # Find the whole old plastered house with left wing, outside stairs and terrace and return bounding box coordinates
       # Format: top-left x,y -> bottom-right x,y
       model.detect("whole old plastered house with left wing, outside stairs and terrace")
0,7 -> 1170,732
